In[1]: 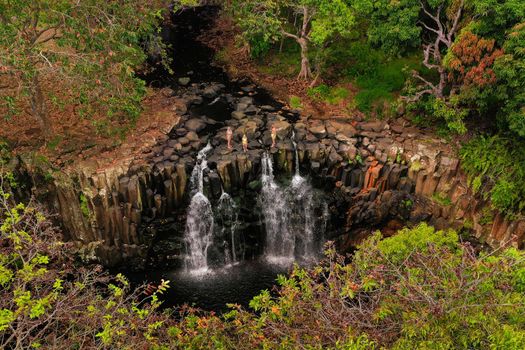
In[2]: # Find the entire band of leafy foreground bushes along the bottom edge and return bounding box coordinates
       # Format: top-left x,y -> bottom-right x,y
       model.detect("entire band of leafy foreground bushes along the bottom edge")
0,174 -> 525,349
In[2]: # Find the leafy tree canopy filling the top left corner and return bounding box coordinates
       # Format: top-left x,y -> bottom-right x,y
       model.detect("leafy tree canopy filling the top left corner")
0,0 -> 164,136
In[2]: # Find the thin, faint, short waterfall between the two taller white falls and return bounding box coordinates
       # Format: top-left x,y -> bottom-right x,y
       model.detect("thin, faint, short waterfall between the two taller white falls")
217,191 -> 243,265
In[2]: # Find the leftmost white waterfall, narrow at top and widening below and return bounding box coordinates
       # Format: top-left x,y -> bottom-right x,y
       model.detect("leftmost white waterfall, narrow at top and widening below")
185,144 -> 214,272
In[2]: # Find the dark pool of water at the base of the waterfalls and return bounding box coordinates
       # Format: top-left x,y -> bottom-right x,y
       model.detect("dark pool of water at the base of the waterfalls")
127,259 -> 290,312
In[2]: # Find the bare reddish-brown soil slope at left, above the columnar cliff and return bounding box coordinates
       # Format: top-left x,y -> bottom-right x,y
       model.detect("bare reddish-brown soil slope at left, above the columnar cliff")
0,90 -> 180,166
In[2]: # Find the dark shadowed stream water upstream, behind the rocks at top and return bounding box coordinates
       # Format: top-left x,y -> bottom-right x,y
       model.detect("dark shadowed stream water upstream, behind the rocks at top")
142,6 -> 299,122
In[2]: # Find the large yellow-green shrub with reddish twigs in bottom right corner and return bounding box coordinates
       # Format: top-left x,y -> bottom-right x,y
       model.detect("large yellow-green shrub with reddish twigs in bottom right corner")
242,224 -> 525,349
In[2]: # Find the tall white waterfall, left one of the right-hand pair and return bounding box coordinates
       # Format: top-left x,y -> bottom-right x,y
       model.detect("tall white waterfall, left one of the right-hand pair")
260,153 -> 295,262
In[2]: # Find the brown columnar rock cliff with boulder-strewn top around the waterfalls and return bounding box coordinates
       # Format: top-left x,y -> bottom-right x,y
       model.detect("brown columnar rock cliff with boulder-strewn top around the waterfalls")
12,84 -> 525,265
